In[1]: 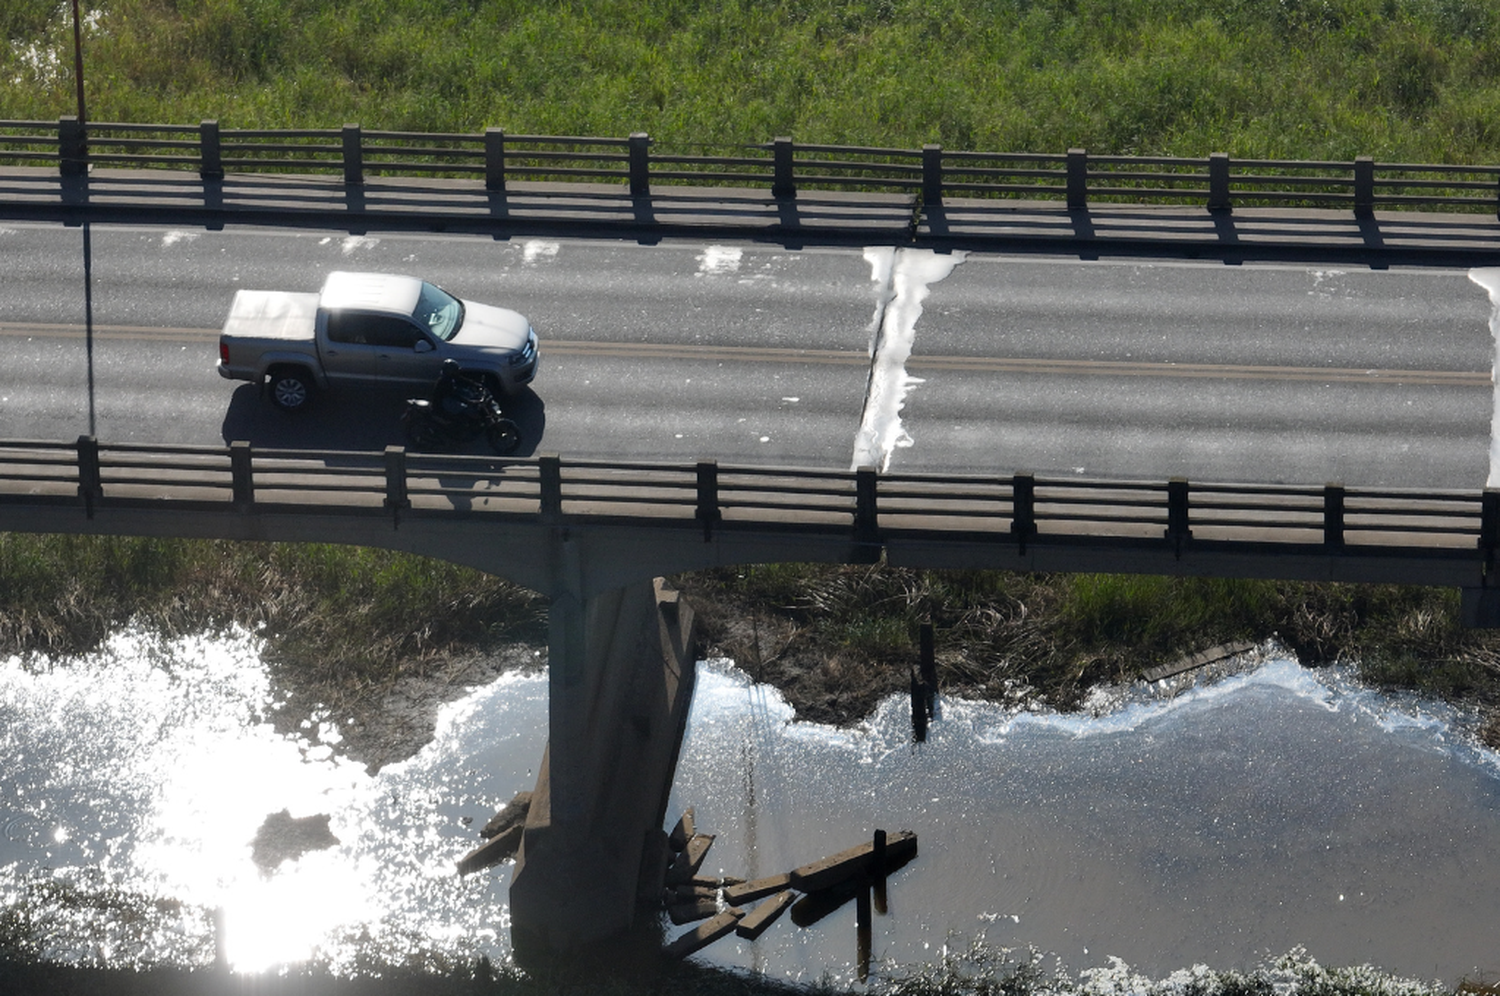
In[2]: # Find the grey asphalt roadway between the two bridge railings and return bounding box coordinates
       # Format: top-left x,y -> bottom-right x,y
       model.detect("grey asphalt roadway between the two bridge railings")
0,224 -> 1496,488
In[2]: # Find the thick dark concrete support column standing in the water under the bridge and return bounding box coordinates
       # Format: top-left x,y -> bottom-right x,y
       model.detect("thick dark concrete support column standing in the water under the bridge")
510,579 -> 698,960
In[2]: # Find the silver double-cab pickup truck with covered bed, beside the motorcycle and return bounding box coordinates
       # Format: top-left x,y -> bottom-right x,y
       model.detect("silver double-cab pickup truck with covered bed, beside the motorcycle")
219,272 -> 537,411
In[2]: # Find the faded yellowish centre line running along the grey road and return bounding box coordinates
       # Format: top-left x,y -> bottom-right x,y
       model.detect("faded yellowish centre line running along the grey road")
0,321 -> 1494,389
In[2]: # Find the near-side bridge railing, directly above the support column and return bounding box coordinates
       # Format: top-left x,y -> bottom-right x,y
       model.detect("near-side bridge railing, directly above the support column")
0,437 -> 1500,564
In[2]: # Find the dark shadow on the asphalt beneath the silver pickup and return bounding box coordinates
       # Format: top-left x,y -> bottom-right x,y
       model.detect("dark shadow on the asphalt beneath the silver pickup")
222,384 -> 546,456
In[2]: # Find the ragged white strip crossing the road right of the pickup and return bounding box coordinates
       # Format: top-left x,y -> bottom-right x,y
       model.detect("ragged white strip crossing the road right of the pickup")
851,246 -> 965,471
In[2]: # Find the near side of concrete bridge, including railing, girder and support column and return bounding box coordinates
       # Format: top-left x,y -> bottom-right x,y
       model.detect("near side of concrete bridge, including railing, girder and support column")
0,437 -> 1500,953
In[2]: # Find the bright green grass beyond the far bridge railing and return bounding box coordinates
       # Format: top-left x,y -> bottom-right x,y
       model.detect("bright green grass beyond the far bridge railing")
0,0 -> 1500,162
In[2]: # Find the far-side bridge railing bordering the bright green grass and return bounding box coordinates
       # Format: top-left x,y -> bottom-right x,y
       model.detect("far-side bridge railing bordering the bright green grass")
0,117 -> 1500,218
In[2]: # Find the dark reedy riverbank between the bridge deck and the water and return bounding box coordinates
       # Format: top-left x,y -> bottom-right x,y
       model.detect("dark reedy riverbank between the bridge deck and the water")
0,534 -> 1500,744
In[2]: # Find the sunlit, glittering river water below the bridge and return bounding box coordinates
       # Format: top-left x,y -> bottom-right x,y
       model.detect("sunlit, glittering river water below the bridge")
0,633 -> 1500,984
